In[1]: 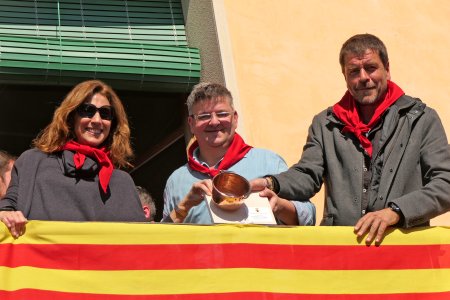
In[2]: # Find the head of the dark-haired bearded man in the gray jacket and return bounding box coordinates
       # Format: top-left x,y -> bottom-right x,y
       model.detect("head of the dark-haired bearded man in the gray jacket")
339,33 -> 391,106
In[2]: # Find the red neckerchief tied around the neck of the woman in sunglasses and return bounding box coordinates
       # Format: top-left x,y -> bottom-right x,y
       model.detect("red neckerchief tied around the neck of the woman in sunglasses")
61,141 -> 114,193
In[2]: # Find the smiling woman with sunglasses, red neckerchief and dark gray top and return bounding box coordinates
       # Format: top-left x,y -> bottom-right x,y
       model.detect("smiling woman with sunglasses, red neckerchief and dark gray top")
0,80 -> 146,238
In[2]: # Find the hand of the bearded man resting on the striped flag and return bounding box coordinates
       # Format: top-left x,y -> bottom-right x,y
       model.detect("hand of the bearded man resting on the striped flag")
354,208 -> 400,245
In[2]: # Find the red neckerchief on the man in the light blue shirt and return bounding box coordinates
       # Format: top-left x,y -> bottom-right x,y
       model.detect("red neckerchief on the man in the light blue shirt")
188,133 -> 252,177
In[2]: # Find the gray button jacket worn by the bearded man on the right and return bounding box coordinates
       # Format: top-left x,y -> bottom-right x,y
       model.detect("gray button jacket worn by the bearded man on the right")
275,96 -> 450,227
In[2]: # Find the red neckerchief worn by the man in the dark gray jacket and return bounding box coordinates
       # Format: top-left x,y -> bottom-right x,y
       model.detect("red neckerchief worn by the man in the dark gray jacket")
333,81 -> 405,157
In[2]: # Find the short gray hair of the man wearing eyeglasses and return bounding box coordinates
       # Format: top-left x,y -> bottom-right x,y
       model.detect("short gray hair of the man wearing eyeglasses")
186,82 -> 234,115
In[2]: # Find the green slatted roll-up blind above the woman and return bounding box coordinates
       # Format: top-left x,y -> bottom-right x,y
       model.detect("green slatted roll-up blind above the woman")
0,0 -> 200,91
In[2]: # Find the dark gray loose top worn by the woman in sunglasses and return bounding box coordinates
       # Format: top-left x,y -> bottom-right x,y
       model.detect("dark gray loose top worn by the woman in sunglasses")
0,149 -> 146,222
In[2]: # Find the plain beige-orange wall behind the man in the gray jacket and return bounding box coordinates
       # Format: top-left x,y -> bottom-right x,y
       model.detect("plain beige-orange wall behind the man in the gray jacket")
218,0 -> 450,225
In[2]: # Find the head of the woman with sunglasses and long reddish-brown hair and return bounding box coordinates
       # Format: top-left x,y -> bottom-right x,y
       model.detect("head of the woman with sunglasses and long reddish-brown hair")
33,80 -> 133,168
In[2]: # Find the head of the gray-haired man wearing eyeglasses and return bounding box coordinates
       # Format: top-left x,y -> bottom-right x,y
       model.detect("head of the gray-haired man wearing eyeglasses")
186,82 -> 238,155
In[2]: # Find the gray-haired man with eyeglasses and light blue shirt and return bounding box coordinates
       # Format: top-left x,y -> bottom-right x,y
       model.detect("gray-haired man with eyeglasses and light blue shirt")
163,83 -> 315,225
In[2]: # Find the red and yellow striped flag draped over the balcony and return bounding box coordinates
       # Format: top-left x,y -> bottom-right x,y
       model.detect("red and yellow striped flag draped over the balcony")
0,221 -> 450,300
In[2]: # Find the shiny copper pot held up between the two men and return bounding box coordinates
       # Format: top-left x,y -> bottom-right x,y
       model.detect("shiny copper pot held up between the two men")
212,171 -> 250,210
